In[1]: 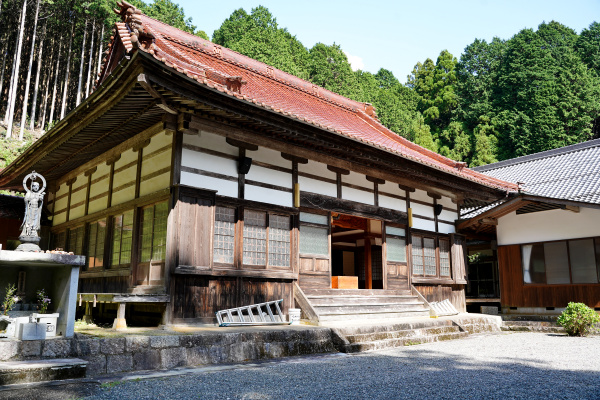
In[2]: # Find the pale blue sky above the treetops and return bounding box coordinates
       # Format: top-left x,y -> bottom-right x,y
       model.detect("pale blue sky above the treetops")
174,0 -> 600,83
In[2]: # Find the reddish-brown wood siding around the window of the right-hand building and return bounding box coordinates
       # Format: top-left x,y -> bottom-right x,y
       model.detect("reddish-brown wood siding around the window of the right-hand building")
498,244 -> 600,307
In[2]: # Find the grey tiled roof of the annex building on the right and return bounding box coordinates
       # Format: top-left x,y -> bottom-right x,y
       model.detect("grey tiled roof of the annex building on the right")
473,139 -> 600,204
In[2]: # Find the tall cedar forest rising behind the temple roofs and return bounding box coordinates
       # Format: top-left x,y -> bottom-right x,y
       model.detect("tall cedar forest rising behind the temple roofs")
0,0 -> 600,168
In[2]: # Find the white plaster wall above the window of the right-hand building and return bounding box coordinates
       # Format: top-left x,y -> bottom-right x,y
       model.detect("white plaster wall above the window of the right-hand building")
496,207 -> 600,246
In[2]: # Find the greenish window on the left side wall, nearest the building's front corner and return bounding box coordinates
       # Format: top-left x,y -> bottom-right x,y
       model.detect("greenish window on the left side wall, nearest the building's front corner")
140,201 -> 169,262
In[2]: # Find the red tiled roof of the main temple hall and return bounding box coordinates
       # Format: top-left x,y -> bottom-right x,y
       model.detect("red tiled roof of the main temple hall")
101,2 -> 517,191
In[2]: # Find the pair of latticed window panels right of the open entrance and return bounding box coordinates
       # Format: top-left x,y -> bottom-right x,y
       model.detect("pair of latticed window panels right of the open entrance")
412,234 -> 451,278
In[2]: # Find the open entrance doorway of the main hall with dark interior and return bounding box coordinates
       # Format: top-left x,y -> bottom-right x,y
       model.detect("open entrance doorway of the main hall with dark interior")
331,213 -> 383,289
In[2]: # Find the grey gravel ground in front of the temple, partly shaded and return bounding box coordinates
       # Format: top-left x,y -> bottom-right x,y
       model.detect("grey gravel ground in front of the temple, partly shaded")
86,333 -> 600,400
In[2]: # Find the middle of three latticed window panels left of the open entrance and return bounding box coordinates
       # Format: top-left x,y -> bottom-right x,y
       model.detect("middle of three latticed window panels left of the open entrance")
243,211 -> 267,265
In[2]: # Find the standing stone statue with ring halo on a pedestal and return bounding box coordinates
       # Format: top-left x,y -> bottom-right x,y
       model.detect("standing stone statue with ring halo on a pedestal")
15,171 -> 46,251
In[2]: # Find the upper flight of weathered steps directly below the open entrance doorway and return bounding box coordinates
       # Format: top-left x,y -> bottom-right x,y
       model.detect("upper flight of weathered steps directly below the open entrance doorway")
304,289 -> 429,324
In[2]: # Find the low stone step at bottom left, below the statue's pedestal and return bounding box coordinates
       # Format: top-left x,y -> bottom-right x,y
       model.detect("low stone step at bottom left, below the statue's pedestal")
0,358 -> 88,386
